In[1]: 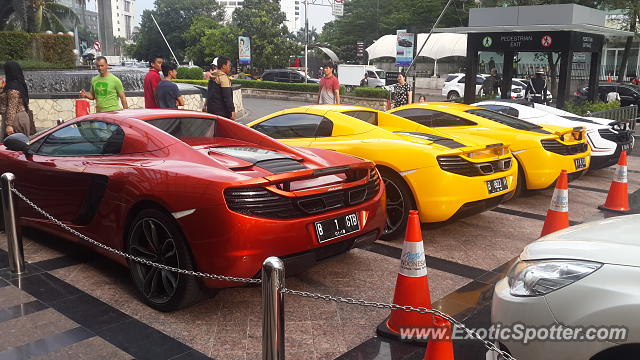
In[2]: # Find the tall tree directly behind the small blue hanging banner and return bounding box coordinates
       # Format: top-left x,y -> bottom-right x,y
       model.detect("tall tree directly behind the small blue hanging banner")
231,0 -> 300,69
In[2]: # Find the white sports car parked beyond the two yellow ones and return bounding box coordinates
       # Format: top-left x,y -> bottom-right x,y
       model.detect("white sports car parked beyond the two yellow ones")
473,99 -> 634,169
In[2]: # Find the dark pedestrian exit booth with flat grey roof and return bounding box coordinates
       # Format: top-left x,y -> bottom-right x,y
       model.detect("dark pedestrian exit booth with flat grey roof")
438,4 -> 632,108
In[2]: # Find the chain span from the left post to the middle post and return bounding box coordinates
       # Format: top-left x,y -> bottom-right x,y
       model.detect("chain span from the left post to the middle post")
11,188 -> 262,284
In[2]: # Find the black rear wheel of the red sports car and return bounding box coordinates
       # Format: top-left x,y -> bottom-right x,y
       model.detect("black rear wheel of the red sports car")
126,209 -> 202,312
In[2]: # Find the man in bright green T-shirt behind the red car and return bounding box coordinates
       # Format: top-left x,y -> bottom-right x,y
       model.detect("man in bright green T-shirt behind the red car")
80,56 -> 129,112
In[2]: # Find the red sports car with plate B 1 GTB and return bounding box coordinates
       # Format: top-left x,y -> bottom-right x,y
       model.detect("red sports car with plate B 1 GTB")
0,110 -> 385,311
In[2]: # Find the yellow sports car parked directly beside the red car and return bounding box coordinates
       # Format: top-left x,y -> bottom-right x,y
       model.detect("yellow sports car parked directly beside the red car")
248,105 -> 518,238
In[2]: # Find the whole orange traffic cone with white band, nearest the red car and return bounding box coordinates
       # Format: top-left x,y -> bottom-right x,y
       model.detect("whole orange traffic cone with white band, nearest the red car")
377,210 -> 433,343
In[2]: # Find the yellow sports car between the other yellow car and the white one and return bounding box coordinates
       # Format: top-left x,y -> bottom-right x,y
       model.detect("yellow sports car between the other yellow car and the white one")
389,103 -> 591,195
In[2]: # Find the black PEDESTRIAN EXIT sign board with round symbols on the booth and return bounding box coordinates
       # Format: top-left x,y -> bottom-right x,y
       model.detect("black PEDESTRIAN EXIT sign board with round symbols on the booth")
467,31 -> 604,52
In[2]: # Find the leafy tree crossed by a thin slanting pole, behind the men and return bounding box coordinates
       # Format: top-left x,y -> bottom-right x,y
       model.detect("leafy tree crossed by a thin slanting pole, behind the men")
132,0 -> 224,60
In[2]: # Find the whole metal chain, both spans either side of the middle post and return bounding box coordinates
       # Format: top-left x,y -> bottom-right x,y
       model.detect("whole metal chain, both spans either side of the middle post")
11,188 -> 516,360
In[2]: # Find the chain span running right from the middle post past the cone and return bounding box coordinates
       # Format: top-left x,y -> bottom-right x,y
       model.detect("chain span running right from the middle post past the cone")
282,288 -> 516,360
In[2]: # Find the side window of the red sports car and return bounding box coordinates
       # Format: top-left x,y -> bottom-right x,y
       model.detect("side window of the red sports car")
32,120 -> 124,156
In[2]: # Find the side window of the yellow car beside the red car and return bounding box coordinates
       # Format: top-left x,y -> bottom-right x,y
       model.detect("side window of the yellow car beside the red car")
253,113 -> 333,139
